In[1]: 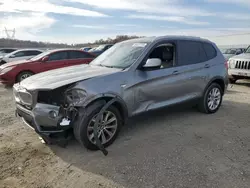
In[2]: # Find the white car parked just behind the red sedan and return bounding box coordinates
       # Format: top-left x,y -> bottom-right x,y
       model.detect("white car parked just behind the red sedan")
0,49 -> 43,65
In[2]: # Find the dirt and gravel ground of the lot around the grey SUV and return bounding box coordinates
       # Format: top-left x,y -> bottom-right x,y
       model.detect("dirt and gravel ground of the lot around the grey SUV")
0,83 -> 250,188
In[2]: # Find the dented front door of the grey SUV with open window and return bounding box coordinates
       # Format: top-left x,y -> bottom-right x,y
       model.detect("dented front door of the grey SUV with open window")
132,41 -> 184,114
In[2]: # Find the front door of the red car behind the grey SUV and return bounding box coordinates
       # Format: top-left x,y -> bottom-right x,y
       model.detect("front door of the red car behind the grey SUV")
41,51 -> 69,72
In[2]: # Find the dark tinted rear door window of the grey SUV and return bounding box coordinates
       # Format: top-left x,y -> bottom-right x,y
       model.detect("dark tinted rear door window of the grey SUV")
178,41 -> 207,65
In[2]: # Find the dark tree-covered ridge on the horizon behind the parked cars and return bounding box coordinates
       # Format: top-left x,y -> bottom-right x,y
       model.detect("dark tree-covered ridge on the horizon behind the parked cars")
0,35 -> 142,48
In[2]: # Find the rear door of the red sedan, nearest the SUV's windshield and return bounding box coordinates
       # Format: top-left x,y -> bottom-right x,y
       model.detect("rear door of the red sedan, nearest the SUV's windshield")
66,50 -> 94,66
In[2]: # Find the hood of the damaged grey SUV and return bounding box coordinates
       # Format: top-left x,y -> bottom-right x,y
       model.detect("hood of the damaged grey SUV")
20,65 -> 121,90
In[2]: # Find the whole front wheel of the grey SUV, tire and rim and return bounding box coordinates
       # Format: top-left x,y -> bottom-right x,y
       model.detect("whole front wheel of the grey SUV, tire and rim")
74,105 -> 122,150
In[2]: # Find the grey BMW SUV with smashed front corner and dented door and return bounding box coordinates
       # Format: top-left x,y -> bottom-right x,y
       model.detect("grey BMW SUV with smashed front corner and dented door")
14,36 -> 228,150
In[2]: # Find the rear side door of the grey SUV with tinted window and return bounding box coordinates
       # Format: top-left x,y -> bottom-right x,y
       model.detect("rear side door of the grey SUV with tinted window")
176,40 -> 210,99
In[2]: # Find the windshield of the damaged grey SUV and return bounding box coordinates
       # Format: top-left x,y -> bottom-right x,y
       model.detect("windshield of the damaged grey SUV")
90,42 -> 147,69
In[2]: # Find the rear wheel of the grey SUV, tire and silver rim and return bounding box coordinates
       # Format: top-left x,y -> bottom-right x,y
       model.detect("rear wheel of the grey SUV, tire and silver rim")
199,83 -> 223,114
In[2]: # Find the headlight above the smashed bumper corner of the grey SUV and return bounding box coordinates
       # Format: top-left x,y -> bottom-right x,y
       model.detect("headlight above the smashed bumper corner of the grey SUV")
65,89 -> 87,105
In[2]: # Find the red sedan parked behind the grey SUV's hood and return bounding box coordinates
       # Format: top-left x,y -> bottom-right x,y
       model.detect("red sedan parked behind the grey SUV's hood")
0,49 -> 95,85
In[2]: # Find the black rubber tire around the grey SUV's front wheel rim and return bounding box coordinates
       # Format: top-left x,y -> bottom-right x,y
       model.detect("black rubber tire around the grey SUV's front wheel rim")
73,105 -> 123,150
